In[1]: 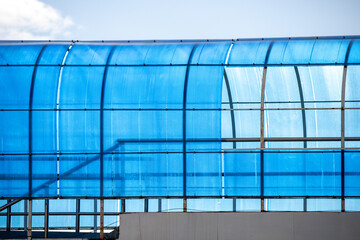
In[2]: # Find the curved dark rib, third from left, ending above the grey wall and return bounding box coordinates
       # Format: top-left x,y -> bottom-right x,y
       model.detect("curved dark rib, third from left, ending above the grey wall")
182,44 -> 197,206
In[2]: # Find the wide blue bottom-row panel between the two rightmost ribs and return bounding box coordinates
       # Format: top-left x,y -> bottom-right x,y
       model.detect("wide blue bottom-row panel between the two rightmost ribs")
264,151 -> 341,196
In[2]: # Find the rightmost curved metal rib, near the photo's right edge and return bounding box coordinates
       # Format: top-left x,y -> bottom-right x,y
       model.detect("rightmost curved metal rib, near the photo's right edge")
341,40 -> 353,212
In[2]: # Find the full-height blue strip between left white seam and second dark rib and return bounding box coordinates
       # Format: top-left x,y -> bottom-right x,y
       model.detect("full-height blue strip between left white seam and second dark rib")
59,45 -> 111,197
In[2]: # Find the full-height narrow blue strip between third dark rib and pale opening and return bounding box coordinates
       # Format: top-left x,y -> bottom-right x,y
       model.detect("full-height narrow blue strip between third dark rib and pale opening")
186,43 -> 230,196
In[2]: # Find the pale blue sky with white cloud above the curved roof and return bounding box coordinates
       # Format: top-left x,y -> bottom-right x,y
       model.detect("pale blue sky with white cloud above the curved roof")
0,0 -> 360,40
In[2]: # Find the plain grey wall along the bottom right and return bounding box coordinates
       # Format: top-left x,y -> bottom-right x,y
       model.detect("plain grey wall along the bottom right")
120,212 -> 360,240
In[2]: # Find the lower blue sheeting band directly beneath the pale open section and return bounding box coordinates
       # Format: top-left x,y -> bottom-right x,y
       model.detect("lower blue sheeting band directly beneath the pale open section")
224,150 -> 350,197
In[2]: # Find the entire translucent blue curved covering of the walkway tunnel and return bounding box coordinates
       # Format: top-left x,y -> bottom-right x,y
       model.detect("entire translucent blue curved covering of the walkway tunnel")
0,37 -> 360,198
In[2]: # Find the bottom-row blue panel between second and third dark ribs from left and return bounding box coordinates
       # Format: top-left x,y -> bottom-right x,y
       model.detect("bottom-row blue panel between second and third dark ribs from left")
104,154 -> 183,197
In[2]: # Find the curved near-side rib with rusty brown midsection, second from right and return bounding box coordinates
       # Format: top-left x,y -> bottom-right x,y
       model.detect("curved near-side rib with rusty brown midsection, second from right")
260,41 -> 274,212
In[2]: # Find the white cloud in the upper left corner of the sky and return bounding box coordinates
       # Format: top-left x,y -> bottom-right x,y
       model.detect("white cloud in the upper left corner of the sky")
0,0 -> 74,40
